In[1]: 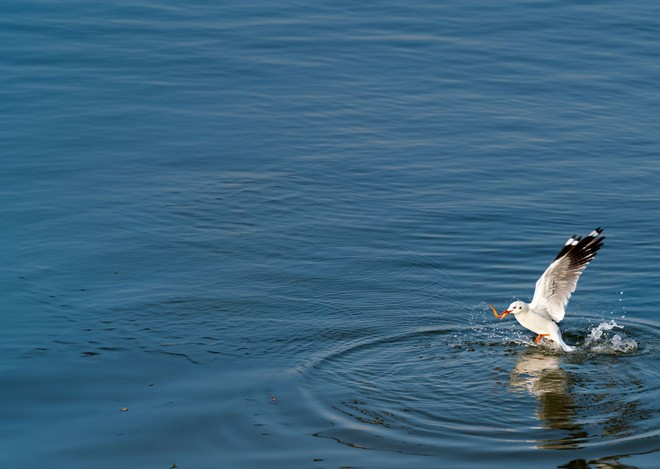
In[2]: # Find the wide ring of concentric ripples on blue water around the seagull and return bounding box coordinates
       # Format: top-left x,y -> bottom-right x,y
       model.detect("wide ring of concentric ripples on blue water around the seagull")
303,316 -> 660,462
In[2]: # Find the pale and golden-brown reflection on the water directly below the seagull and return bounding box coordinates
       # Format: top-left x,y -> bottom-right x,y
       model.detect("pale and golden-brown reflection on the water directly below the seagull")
509,350 -> 587,449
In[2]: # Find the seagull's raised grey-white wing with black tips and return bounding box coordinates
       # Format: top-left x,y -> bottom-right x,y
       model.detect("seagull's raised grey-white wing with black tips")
530,228 -> 605,322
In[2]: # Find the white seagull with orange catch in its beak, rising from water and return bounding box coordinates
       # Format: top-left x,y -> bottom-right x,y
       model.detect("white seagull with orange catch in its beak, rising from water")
490,228 -> 605,352
